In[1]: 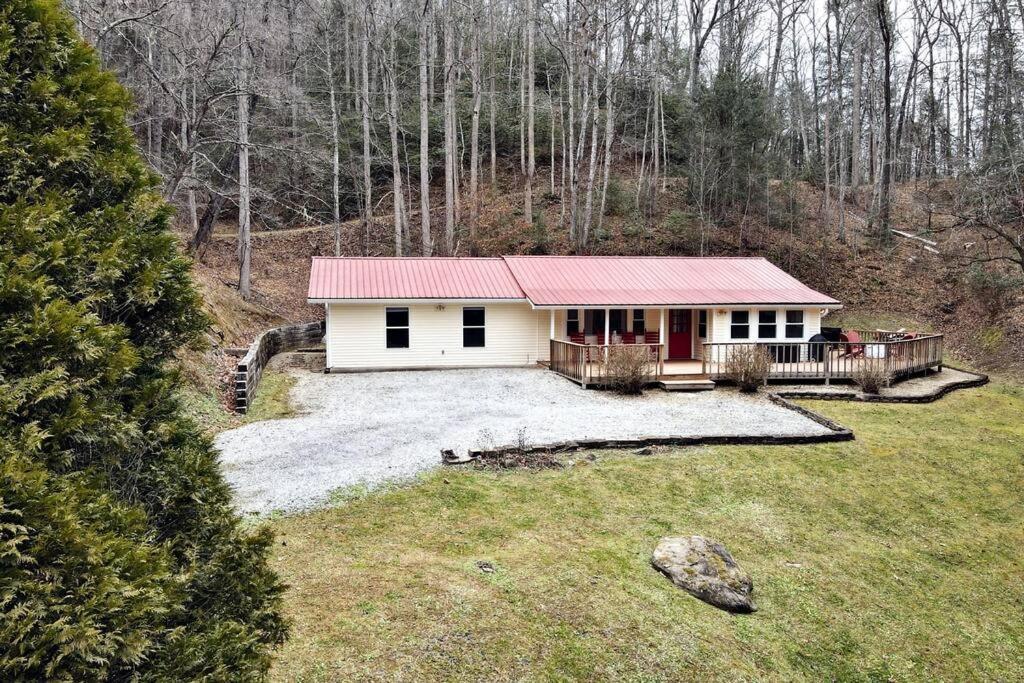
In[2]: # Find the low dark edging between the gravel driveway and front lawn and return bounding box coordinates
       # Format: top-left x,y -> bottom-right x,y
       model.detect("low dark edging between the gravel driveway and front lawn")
441,393 -> 854,465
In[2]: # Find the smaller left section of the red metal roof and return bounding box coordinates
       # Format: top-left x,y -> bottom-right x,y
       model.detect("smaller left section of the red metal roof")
308,256 -> 526,299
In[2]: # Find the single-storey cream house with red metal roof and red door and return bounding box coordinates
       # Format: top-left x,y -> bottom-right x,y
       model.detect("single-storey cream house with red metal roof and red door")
308,256 -> 840,385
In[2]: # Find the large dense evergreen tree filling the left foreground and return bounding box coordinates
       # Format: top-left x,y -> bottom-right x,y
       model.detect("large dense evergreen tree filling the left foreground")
0,0 -> 287,680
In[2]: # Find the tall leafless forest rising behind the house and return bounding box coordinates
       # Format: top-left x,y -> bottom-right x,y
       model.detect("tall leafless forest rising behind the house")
67,0 -> 1024,296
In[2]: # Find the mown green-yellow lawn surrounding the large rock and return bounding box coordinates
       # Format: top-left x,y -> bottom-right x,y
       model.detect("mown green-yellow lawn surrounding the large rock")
273,384 -> 1024,681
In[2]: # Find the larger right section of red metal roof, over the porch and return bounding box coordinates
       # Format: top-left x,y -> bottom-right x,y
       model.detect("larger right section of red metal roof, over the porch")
505,256 -> 839,306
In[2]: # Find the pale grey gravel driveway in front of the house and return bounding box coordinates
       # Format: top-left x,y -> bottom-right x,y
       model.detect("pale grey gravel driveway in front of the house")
217,369 -> 828,513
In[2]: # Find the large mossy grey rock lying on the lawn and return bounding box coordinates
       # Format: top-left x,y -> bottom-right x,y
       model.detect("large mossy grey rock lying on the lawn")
651,536 -> 757,613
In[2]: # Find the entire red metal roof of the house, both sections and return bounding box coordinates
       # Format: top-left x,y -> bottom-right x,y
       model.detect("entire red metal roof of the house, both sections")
308,256 -> 839,306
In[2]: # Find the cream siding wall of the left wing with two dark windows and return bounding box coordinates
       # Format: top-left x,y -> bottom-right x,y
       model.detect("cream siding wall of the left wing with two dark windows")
325,301 -> 550,370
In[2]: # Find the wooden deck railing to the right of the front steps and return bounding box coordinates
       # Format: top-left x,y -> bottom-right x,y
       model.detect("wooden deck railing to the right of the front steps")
702,332 -> 943,380
